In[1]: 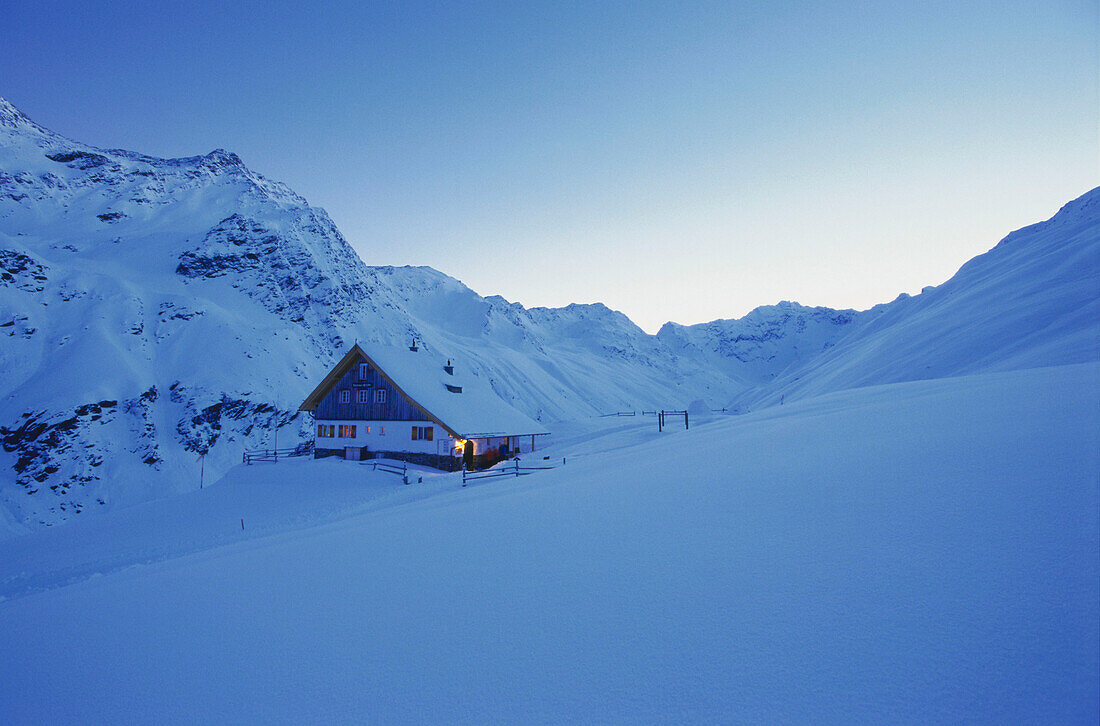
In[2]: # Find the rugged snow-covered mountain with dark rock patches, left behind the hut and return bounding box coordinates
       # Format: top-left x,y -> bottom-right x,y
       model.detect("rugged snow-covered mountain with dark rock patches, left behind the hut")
0,99 -> 729,524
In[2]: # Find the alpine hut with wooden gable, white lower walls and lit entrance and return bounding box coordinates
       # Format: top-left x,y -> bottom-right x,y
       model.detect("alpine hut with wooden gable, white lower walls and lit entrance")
299,342 -> 549,471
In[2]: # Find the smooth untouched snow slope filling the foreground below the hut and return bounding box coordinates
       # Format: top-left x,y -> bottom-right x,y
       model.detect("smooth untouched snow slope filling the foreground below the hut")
0,363 -> 1100,724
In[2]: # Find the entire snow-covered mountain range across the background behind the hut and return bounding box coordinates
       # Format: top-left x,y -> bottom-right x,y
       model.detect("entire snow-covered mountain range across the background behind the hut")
0,99 -> 1100,524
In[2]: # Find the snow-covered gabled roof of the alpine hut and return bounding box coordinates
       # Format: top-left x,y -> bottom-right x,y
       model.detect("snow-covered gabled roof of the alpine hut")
300,344 -> 549,439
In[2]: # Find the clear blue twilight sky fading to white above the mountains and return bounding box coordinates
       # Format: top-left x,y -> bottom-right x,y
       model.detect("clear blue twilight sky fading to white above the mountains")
0,0 -> 1100,331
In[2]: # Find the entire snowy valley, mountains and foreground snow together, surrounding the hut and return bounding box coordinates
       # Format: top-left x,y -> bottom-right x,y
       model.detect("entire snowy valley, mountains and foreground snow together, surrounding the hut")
0,93 -> 1100,724
